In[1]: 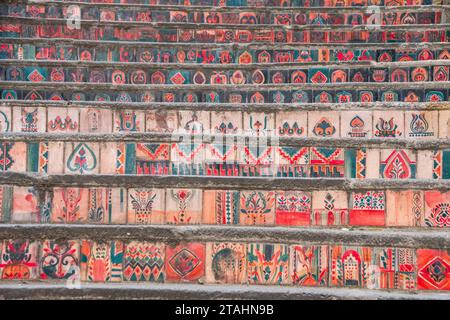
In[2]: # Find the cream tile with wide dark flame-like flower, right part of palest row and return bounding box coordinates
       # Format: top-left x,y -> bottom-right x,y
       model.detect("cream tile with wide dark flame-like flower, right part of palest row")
373,111 -> 405,138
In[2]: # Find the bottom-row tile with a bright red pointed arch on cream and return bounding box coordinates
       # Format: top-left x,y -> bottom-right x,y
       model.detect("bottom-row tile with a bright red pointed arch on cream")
330,246 -> 373,288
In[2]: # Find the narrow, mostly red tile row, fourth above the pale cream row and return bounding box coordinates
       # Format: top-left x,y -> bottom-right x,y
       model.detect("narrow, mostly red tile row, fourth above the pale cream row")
0,23 -> 448,44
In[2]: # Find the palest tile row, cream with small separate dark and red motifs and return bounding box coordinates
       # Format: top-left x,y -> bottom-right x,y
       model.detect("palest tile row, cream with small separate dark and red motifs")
0,107 -> 450,138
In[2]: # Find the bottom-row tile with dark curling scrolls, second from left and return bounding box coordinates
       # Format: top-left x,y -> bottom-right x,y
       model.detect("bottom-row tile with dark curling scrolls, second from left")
39,240 -> 80,280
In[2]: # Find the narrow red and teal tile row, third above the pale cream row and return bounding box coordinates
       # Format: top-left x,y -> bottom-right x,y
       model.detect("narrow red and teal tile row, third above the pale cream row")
0,44 -> 450,65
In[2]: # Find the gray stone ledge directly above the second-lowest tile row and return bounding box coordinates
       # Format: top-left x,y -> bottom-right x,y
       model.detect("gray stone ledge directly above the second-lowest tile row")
0,171 -> 450,192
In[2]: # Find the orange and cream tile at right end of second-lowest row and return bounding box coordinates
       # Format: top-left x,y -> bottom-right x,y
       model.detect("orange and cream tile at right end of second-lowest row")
424,191 -> 450,228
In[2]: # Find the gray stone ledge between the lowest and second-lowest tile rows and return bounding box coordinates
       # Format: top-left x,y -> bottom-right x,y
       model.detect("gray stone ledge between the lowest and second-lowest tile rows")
0,224 -> 450,250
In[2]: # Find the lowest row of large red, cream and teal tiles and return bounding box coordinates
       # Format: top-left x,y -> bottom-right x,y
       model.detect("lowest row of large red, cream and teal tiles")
0,240 -> 450,291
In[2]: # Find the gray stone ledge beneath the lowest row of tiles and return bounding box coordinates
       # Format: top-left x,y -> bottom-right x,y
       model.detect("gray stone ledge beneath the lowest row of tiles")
0,282 -> 450,300
